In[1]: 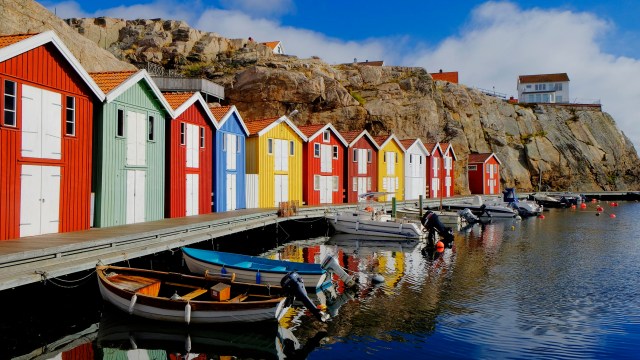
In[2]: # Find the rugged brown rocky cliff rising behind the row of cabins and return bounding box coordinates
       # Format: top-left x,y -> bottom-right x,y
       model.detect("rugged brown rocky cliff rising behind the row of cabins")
67,18 -> 640,193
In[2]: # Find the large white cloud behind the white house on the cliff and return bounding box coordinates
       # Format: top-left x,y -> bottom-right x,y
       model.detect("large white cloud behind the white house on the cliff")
406,2 -> 640,146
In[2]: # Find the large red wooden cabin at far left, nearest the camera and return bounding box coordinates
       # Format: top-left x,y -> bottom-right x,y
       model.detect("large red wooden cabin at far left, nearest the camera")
0,31 -> 104,240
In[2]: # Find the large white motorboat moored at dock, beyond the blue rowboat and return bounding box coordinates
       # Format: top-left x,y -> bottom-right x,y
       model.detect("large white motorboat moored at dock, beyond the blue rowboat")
325,192 -> 426,240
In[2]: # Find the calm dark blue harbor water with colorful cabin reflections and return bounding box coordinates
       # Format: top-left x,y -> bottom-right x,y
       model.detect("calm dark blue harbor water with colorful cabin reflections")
0,202 -> 640,359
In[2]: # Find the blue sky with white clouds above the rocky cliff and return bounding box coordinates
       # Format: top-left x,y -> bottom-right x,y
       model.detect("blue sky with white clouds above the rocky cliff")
41,0 -> 640,149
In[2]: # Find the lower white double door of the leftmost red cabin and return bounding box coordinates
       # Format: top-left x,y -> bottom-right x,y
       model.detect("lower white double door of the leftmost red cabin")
20,165 -> 60,237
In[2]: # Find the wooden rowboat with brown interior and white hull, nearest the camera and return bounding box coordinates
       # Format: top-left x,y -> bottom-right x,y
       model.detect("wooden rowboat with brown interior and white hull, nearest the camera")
96,266 -> 291,324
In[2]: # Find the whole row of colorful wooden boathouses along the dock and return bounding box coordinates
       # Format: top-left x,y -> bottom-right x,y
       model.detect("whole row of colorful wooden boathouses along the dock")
0,31 -> 499,240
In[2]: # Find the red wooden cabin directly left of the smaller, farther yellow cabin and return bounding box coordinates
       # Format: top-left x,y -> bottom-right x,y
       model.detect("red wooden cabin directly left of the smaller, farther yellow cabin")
340,130 -> 379,203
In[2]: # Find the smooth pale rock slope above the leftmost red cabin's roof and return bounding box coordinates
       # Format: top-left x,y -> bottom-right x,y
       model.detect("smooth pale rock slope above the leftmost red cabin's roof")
0,0 -> 135,71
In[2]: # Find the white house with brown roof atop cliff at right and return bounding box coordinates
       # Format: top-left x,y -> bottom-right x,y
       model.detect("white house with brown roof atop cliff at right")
518,73 -> 569,103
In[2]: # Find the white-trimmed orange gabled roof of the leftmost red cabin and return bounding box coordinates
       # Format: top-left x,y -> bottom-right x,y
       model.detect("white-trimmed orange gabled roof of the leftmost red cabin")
0,30 -> 105,101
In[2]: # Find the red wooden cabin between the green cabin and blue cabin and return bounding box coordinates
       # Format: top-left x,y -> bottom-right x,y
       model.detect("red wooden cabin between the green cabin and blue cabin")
164,92 -> 215,218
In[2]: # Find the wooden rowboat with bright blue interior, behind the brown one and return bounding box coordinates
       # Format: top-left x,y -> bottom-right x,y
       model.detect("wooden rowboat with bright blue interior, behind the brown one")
182,247 -> 329,288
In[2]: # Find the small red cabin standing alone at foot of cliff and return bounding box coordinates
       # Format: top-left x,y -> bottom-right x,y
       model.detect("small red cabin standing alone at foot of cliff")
467,153 -> 502,195
